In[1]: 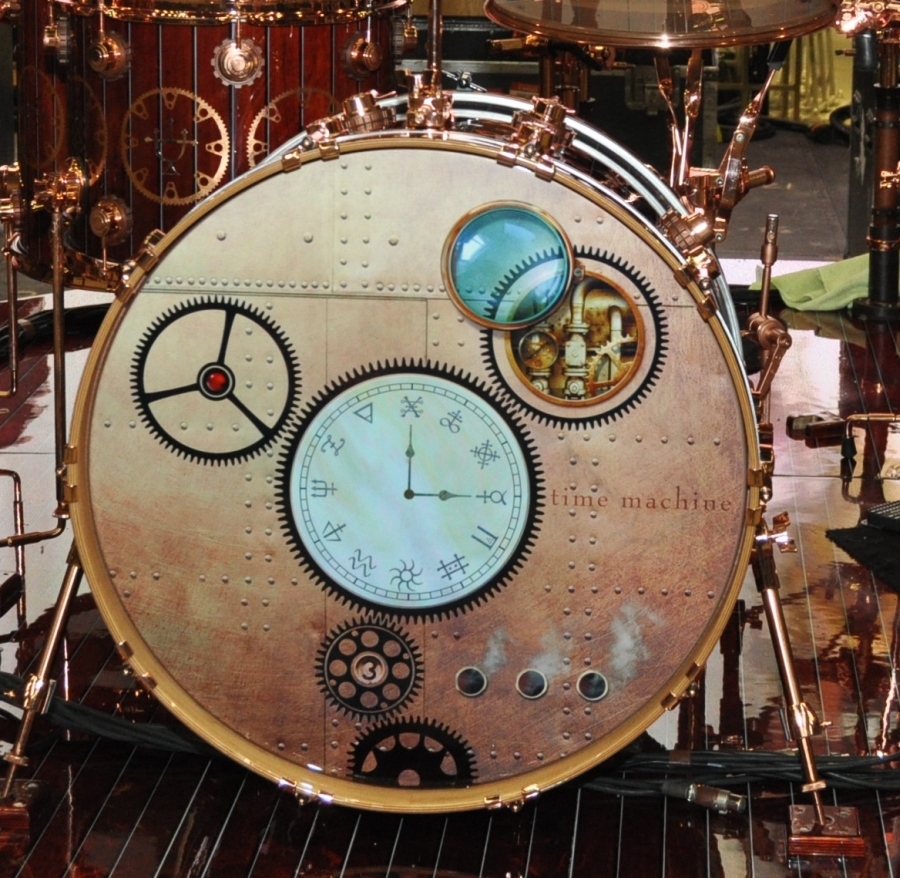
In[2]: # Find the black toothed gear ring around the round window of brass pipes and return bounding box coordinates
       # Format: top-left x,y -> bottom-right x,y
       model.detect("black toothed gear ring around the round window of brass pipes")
481,247 -> 669,427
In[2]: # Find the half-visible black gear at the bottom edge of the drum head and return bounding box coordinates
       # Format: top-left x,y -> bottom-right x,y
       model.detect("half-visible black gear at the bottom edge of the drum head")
350,719 -> 477,788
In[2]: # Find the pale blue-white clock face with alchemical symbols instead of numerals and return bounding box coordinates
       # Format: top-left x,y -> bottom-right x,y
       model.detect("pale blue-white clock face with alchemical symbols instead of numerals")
283,369 -> 535,615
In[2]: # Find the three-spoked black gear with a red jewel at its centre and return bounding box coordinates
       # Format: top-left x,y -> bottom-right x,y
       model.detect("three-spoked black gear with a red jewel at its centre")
131,297 -> 300,463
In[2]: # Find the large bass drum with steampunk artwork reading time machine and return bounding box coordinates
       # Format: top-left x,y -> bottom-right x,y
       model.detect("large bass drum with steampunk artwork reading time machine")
69,99 -> 760,812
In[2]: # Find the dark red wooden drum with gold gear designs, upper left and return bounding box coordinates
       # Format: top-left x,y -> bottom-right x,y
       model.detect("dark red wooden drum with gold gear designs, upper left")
16,0 -> 392,289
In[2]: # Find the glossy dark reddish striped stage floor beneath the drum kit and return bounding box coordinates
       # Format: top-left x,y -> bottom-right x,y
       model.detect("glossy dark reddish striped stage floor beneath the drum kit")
0,292 -> 900,878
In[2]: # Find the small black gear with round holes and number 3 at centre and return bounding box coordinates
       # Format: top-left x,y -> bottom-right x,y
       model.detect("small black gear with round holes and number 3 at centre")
316,619 -> 423,718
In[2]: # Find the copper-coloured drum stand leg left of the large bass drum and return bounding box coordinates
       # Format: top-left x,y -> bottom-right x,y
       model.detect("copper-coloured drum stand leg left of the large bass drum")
0,545 -> 83,835
